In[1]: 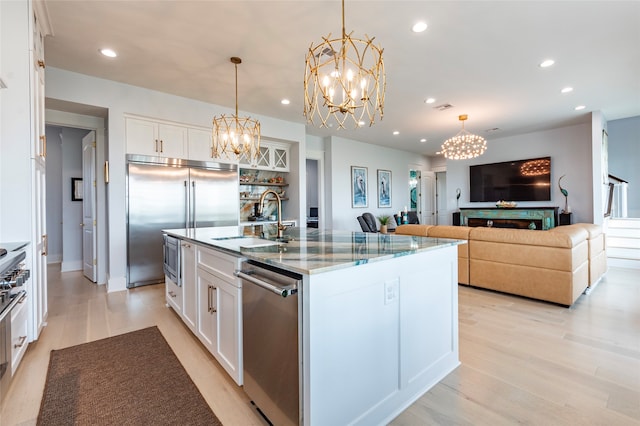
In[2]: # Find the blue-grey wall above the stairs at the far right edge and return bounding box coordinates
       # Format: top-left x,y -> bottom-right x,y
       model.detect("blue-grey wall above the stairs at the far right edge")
607,116 -> 640,218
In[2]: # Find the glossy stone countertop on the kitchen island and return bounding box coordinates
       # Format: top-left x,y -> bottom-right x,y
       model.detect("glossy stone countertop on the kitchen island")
164,226 -> 465,274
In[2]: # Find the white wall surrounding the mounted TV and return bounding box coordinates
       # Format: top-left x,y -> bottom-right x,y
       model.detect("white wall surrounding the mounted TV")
446,123 -> 593,222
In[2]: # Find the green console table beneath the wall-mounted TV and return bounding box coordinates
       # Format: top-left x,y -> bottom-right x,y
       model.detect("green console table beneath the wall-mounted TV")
460,207 -> 558,231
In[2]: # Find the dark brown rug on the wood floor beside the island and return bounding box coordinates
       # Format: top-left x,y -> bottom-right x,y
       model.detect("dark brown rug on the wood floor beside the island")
37,327 -> 222,426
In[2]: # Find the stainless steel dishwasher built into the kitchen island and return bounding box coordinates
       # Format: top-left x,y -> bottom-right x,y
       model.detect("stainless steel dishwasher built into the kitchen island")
236,260 -> 302,426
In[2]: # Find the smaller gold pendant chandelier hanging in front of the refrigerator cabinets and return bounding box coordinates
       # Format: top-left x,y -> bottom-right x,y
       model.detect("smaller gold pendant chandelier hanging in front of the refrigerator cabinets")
211,56 -> 260,159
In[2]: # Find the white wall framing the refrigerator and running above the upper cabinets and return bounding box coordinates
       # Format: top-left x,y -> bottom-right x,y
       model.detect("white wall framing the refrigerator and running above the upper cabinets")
46,67 -> 306,291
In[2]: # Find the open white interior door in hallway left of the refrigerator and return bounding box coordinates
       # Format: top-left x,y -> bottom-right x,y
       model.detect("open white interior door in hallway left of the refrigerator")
82,130 -> 97,282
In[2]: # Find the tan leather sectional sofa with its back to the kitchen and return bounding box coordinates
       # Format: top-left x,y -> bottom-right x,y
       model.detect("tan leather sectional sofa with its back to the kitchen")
396,224 -> 606,306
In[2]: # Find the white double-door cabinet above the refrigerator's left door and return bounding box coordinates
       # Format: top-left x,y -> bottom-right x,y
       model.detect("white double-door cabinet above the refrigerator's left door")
125,117 -> 188,158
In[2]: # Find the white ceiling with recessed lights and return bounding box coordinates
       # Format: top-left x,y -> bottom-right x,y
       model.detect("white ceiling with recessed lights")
45,0 -> 640,155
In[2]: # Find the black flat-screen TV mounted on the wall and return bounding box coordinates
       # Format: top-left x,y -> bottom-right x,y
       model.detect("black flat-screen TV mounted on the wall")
469,157 -> 551,202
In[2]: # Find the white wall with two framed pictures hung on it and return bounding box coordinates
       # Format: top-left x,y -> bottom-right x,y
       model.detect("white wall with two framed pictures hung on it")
324,137 -> 430,231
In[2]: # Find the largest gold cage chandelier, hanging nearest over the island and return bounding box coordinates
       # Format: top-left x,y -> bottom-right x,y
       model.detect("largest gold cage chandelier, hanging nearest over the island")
304,0 -> 386,129
